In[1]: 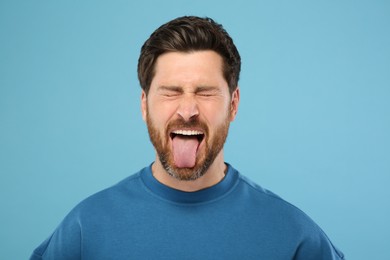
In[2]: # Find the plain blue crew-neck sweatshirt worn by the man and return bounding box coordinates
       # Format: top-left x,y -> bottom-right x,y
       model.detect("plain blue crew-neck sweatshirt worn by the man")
30,165 -> 343,260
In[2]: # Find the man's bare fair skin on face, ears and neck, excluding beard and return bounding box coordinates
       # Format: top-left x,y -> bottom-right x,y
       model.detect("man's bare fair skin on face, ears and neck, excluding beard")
141,50 -> 240,191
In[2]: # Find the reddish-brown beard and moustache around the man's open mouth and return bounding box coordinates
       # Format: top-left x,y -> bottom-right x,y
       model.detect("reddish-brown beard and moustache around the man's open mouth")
146,107 -> 230,181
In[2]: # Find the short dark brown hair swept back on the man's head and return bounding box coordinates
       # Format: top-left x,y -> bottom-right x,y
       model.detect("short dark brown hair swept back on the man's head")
138,16 -> 241,95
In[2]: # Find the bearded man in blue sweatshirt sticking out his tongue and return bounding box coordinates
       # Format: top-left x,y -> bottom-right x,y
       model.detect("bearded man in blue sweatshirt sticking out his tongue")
31,17 -> 343,260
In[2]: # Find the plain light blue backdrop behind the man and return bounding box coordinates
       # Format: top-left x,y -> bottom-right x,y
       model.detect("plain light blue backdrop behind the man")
0,0 -> 390,259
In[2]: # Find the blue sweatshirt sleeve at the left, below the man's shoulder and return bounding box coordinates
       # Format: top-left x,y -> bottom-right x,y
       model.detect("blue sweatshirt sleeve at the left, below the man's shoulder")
30,211 -> 81,260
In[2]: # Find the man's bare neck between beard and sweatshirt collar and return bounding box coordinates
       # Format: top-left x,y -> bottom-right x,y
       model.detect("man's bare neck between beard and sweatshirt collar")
152,151 -> 226,192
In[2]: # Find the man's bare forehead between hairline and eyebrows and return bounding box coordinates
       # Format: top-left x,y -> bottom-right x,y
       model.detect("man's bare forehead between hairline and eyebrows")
152,50 -> 226,85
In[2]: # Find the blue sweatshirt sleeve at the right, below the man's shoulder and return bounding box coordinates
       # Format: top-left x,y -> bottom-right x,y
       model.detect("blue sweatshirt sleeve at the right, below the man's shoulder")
294,230 -> 345,260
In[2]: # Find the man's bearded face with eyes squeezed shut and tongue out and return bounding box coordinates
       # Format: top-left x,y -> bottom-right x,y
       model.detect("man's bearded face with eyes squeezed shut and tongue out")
142,51 -> 239,180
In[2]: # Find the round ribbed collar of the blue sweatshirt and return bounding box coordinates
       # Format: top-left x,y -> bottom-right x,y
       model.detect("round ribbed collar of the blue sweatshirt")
140,164 -> 238,204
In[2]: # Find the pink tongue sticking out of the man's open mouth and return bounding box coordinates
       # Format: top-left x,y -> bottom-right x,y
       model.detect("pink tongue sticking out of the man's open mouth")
172,135 -> 199,168
